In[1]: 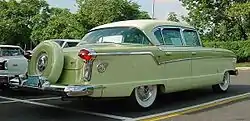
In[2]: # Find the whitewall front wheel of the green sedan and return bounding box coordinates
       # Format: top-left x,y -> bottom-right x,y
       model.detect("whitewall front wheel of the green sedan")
212,72 -> 231,92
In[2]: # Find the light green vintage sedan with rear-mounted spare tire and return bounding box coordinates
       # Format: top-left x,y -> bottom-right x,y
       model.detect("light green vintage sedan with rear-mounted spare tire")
10,20 -> 238,108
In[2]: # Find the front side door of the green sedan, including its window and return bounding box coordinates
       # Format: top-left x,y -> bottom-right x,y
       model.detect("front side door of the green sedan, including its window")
183,29 -> 218,86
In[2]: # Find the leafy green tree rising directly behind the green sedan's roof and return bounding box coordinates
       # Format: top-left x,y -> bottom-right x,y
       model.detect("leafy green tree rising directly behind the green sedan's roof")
77,0 -> 150,29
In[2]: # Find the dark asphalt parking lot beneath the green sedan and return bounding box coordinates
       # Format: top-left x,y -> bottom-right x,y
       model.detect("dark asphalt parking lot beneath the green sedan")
0,71 -> 250,121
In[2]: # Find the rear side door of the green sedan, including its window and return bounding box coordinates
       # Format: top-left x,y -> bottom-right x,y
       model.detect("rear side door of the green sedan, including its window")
154,27 -> 192,91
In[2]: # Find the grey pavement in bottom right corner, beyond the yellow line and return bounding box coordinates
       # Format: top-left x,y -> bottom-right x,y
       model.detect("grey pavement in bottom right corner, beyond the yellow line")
164,100 -> 250,121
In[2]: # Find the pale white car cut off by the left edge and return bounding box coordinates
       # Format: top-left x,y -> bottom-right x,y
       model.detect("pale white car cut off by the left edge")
0,45 -> 28,88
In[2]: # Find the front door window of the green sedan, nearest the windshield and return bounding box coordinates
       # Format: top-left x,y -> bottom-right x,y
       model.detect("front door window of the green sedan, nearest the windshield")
183,30 -> 201,46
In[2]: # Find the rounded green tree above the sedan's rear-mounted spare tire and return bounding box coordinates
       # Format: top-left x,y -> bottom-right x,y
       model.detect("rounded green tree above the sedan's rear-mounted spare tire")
31,8 -> 86,44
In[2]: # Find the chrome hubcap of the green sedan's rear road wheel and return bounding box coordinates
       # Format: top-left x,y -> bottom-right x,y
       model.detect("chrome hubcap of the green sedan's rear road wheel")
137,86 -> 153,102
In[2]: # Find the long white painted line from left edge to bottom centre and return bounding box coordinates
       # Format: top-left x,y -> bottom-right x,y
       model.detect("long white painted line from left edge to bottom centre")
0,96 -> 132,120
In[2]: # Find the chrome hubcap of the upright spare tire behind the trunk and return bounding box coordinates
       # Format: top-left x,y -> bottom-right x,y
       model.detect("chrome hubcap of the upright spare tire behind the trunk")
37,54 -> 48,72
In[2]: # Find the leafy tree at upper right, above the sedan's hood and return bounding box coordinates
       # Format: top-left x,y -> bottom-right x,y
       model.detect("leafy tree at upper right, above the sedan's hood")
179,0 -> 248,41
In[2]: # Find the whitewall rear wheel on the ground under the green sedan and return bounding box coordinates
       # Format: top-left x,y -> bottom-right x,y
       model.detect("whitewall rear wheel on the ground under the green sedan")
131,85 -> 157,109
